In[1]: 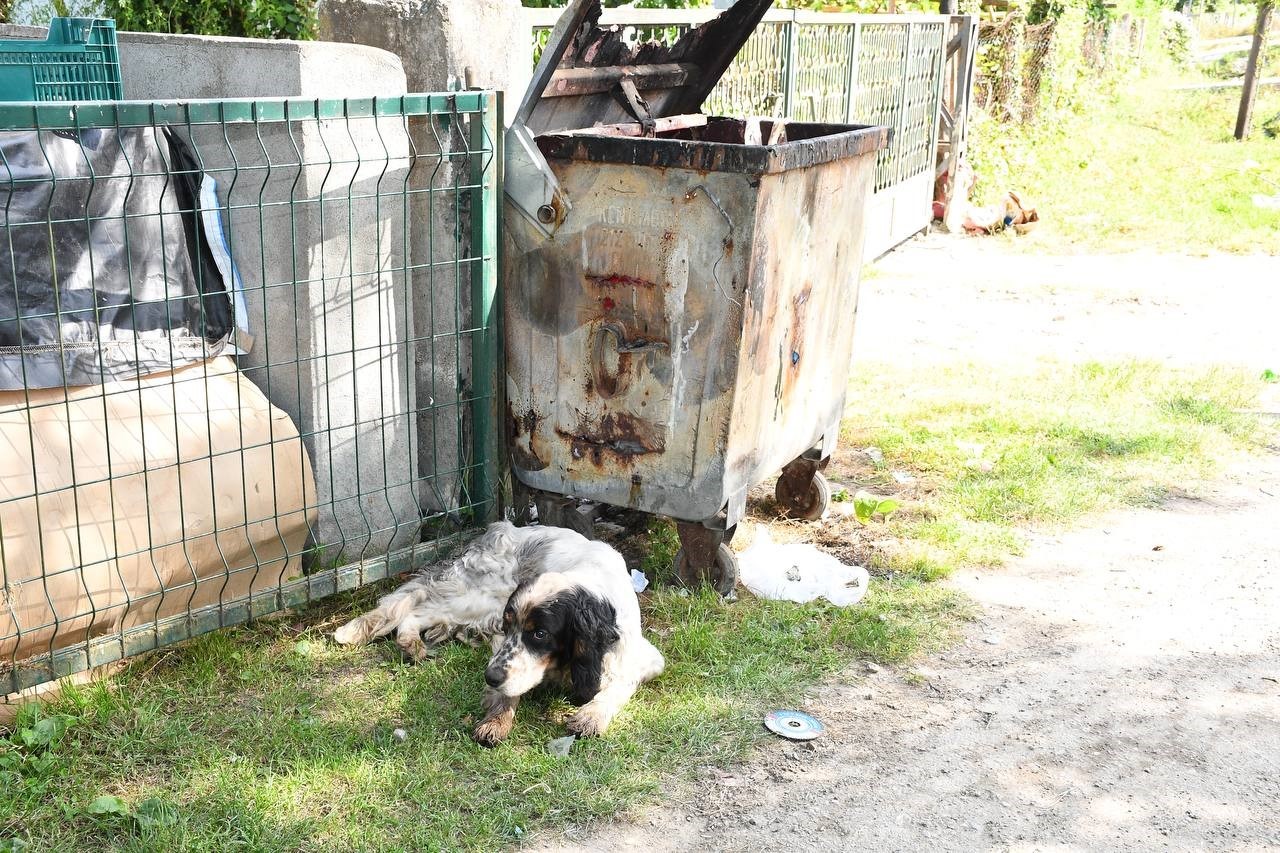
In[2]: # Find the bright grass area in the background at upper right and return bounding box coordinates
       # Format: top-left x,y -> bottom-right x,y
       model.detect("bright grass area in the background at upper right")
970,77 -> 1280,255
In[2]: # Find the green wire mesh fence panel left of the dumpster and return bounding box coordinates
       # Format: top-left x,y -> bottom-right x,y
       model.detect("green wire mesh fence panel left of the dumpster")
0,91 -> 502,693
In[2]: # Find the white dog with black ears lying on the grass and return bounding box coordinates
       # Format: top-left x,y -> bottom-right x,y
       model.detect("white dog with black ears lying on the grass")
334,521 -> 666,745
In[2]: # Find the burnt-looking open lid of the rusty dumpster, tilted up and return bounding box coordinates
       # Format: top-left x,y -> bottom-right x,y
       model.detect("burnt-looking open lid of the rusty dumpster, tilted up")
515,0 -> 772,134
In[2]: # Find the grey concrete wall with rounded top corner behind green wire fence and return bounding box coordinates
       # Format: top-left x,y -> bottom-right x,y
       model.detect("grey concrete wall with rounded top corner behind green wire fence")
119,33 -> 422,564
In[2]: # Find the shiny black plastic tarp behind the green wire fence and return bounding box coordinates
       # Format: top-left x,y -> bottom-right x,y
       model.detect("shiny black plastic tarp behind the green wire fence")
0,128 -> 234,391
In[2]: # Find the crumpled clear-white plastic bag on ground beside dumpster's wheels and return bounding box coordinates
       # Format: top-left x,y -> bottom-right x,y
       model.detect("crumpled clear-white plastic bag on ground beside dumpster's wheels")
739,530 -> 870,607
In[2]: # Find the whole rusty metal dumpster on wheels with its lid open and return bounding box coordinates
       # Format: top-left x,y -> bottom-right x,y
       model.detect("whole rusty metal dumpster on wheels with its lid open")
504,0 -> 888,593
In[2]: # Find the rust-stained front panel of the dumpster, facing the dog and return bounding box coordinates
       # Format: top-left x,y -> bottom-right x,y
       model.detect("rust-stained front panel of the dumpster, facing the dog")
506,160 -> 756,520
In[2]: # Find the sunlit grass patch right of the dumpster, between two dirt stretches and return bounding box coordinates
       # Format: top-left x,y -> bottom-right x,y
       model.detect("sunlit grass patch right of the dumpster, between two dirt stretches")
841,361 -> 1262,580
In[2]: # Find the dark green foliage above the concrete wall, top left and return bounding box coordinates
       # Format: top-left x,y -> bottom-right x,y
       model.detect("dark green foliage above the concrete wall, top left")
105,0 -> 316,40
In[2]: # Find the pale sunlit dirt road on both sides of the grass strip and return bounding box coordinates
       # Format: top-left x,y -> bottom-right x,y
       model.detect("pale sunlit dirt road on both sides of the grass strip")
535,240 -> 1280,852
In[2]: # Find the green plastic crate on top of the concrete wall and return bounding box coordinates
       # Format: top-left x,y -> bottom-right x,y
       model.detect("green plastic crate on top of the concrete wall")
0,18 -> 124,101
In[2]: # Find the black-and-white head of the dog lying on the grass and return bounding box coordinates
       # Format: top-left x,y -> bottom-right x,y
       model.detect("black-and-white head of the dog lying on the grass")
484,573 -> 618,704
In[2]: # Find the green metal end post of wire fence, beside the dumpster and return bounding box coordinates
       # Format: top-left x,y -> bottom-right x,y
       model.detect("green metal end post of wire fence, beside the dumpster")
467,92 -> 502,521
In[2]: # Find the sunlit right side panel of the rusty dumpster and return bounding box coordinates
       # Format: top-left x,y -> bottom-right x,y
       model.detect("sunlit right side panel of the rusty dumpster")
726,146 -> 876,499
